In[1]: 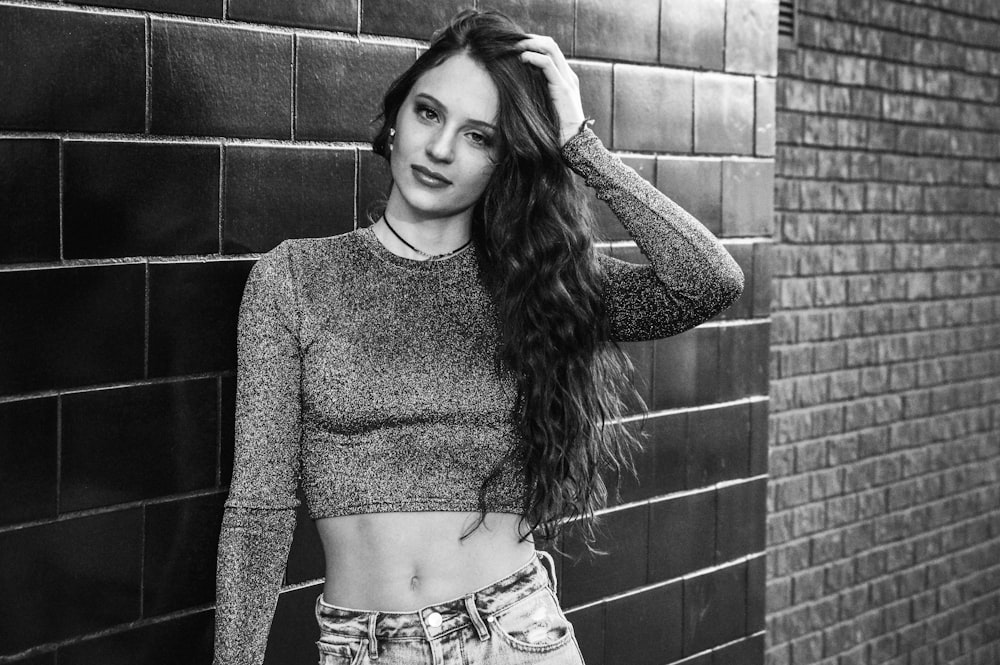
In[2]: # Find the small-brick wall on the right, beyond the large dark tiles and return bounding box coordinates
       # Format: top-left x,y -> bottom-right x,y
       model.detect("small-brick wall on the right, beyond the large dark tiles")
767,0 -> 1000,665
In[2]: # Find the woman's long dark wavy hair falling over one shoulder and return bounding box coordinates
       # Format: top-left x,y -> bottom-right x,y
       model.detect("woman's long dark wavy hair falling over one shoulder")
372,10 -> 641,550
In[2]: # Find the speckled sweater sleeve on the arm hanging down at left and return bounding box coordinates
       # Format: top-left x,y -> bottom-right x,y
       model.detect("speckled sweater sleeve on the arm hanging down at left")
214,242 -> 301,665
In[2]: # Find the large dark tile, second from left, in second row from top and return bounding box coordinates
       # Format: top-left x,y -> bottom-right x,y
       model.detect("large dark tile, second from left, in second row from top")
149,19 -> 292,139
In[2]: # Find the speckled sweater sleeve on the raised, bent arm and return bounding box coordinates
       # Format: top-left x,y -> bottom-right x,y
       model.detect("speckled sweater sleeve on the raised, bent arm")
563,129 -> 743,341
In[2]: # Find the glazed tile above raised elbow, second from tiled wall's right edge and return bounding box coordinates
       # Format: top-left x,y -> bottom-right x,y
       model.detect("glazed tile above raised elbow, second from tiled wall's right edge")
656,157 -> 722,235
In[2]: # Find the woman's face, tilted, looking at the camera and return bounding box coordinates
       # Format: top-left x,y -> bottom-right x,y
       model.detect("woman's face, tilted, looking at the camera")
387,54 -> 499,221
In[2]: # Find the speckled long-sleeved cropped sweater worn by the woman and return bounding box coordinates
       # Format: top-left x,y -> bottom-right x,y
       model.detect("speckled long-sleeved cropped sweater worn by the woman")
215,130 -> 743,665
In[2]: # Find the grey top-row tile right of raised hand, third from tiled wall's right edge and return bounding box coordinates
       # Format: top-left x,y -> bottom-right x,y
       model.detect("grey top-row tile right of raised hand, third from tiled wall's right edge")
576,0 -> 660,62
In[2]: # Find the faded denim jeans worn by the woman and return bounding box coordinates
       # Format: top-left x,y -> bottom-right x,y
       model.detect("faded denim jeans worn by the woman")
316,552 -> 583,665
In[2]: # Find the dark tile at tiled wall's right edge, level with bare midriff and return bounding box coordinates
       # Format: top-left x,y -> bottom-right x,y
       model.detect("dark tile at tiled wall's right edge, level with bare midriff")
715,479 -> 767,564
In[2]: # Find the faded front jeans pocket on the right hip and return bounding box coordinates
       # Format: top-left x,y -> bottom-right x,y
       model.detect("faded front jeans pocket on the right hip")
486,589 -> 573,653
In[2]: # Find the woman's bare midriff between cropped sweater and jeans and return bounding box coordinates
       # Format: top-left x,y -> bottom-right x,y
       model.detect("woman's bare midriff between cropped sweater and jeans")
316,512 -> 534,612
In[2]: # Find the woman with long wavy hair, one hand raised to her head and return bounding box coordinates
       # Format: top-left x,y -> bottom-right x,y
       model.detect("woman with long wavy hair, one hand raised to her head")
216,11 -> 743,665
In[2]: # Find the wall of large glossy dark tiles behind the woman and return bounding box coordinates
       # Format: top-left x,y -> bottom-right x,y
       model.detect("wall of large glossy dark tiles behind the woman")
0,0 -> 777,665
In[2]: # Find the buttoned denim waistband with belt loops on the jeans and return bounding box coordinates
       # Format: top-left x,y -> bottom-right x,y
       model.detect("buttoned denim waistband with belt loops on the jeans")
316,552 -> 555,640
